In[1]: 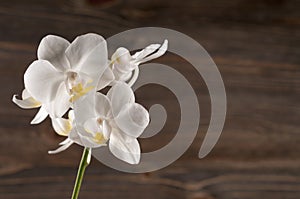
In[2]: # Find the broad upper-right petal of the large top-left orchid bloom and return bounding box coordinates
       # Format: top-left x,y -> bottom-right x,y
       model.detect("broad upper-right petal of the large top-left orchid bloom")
66,33 -> 107,77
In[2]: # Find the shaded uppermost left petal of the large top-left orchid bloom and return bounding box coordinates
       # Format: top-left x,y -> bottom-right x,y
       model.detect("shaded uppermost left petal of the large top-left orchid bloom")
37,35 -> 70,71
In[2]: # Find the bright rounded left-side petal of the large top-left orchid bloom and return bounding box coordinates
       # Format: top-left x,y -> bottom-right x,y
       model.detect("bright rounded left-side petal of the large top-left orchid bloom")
24,60 -> 64,103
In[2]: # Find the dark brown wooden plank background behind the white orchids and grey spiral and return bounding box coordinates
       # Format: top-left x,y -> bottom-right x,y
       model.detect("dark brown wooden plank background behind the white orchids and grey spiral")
0,0 -> 300,199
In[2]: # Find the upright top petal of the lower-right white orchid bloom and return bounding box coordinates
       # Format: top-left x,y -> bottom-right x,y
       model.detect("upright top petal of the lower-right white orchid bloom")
107,82 -> 135,116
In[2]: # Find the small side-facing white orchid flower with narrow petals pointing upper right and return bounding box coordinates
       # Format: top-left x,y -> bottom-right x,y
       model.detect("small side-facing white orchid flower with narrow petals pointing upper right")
110,40 -> 168,86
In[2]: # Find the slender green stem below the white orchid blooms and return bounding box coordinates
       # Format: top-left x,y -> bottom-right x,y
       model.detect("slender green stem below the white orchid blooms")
72,148 -> 91,199
